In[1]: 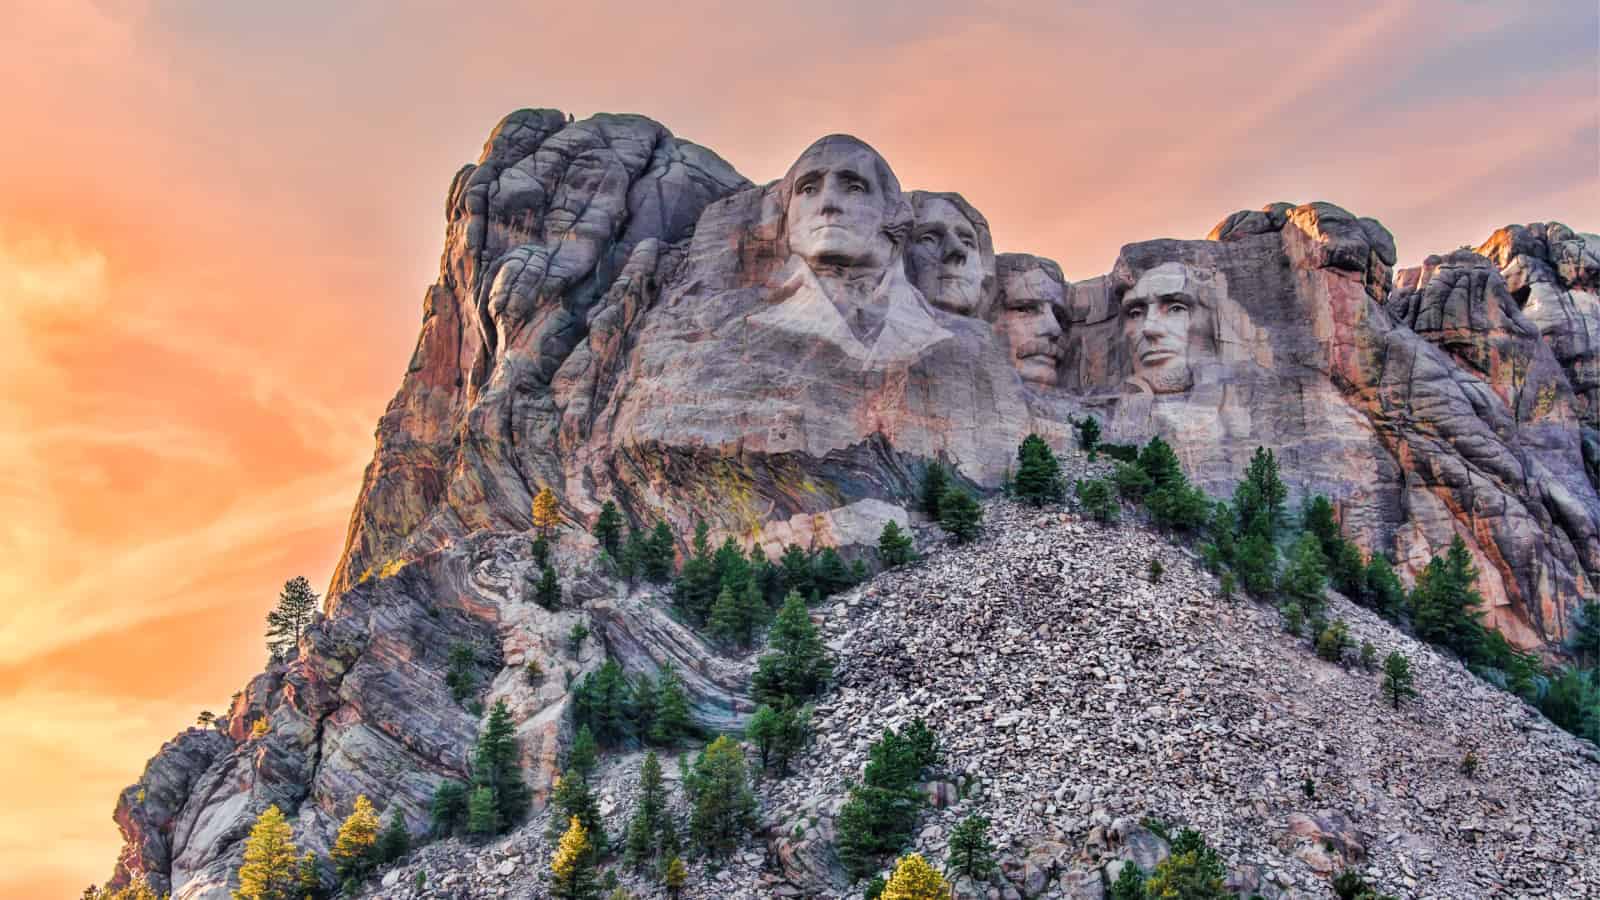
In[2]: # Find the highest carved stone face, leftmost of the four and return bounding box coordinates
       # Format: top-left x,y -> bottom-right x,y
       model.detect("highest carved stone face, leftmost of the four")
784,138 -> 899,269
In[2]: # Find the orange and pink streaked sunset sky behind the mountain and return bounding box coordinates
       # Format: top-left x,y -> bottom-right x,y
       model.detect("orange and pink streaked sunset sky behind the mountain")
0,0 -> 1600,897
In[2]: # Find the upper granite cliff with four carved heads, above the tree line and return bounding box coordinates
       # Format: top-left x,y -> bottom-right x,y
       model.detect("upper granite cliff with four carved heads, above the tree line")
334,110 -> 1600,647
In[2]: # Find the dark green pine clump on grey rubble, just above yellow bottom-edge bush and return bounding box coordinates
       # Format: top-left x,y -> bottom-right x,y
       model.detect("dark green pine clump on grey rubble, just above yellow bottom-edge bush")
834,719 -> 939,878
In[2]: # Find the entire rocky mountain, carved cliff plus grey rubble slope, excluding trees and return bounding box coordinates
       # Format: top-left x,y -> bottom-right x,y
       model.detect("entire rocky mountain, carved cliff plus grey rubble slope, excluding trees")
109,109 -> 1600,898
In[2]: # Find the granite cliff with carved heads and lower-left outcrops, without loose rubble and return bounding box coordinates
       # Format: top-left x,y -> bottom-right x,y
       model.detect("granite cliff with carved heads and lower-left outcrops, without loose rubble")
106,110 -> 1600,898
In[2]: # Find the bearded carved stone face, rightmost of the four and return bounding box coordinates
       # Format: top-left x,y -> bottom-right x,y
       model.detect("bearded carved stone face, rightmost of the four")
1120,263 -> 1211,394
